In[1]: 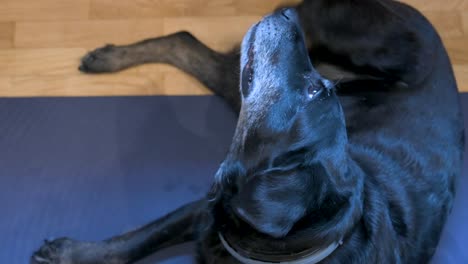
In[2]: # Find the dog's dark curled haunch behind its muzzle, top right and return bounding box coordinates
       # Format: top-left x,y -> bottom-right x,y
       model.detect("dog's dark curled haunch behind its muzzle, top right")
297,0 -> 436,84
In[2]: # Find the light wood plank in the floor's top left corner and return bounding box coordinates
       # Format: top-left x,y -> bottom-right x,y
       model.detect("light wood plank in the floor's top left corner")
0,0 -> 90,21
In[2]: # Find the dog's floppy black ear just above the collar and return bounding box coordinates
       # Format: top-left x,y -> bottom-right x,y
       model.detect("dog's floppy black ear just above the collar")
231,169 -> 315,238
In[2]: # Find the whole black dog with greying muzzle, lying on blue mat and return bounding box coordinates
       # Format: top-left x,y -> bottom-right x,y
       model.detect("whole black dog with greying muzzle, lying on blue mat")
31,0 -> 464,264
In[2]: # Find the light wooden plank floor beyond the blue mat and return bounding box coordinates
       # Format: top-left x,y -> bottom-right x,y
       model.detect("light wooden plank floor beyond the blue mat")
0,0 -> 468,96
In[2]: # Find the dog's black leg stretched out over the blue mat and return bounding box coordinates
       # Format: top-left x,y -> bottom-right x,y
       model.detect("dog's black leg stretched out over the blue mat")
31,200 -> 209,264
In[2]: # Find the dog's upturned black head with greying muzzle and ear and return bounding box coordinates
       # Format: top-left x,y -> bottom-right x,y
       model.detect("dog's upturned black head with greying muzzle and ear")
216,9 -> 347,238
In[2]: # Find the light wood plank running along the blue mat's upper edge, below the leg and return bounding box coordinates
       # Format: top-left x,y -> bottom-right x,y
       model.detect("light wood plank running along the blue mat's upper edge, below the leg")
0,69 -> 212,97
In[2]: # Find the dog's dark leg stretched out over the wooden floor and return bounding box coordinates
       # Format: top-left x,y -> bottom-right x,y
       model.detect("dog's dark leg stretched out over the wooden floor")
79,32 -> 241,110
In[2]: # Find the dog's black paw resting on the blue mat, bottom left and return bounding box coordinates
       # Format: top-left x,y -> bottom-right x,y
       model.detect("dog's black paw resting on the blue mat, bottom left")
30,238 -> 90,264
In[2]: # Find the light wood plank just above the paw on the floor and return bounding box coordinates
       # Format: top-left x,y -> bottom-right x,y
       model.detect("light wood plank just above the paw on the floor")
15,19 -> 163,48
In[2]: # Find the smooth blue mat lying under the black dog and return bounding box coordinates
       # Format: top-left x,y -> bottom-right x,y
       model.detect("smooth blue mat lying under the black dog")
0,95 -> 468,264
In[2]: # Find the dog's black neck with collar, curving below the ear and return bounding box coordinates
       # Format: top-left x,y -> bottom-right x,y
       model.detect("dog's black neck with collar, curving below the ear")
210,155 -> 364,264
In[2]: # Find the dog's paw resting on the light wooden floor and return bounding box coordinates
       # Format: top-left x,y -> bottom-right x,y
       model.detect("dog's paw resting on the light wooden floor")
78,45 -> 125,73
